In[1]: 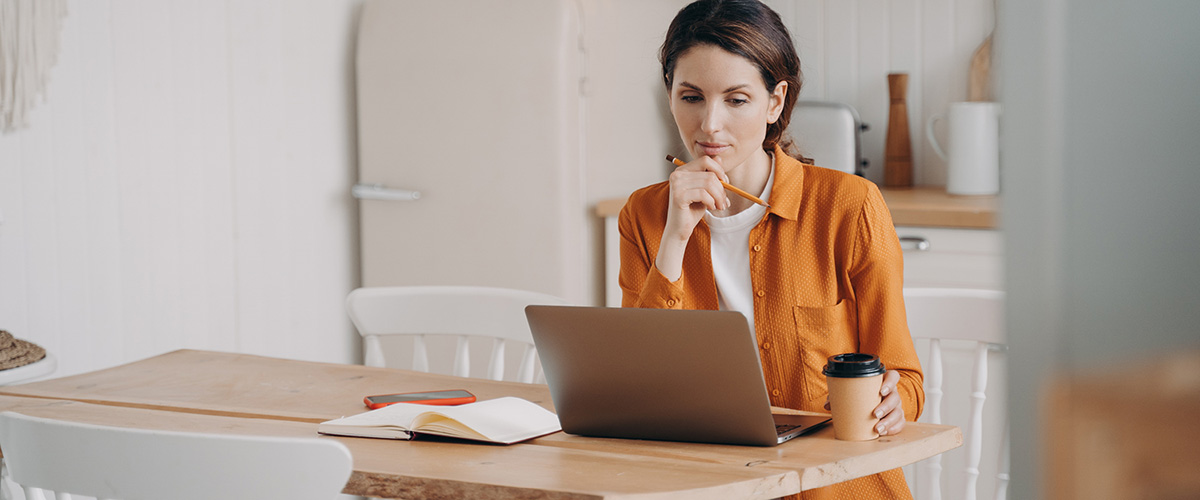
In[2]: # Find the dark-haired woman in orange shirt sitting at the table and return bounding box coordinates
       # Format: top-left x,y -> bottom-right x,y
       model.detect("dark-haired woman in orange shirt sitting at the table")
619,0 -> 924,499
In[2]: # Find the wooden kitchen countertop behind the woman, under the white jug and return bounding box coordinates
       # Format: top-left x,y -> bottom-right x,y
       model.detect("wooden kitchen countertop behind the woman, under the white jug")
595,186 -> 1000,229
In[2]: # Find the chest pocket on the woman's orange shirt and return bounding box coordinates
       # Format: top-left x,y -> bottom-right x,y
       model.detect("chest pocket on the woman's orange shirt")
792,300 -> 858,408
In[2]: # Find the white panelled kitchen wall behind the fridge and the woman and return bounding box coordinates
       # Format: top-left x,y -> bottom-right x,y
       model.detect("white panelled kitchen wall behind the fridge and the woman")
0,0 -> 992,374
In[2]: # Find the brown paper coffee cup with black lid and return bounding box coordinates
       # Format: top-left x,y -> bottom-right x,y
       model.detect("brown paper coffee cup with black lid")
824,353 -> 886,441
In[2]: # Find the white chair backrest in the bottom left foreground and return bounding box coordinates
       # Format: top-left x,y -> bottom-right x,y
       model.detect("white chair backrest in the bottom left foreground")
0,411 -> 352,500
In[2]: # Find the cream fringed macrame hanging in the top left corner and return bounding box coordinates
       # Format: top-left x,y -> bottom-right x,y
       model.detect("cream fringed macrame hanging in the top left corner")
0,0 -> 67,132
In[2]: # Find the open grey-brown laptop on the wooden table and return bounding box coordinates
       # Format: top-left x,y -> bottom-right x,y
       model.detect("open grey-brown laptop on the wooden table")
526,306 -> 829,446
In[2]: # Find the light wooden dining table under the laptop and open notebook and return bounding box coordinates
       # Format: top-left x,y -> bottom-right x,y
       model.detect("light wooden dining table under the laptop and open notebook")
0,350 -> 962,499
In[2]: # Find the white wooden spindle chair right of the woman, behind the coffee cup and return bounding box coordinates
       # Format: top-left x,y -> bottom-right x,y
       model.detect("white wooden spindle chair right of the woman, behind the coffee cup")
904,288 -> 1008,500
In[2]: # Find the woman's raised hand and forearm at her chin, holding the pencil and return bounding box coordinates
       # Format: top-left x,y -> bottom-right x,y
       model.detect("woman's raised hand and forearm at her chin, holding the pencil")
654,156 -> 730,282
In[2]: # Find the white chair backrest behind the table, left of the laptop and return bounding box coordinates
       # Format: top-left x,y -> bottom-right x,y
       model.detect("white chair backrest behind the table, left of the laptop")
346,287 -> 566,384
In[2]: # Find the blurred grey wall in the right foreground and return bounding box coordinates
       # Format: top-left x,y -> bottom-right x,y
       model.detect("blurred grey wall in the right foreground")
996,0 -> 1200,499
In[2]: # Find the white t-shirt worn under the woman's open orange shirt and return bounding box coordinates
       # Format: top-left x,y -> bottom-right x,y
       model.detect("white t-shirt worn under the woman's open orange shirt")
704,158 -> 775,338
